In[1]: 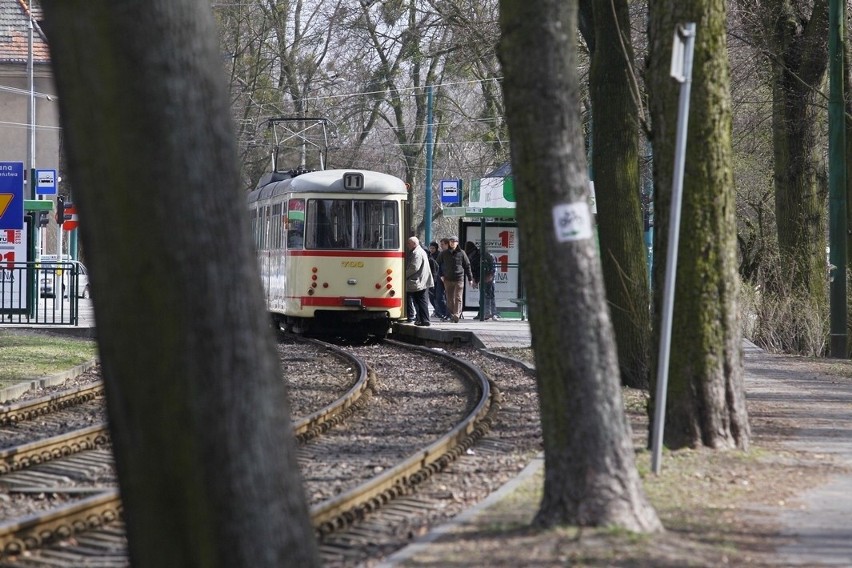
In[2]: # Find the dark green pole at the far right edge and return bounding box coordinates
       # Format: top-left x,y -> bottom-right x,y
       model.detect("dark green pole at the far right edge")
828,0 -> 848,359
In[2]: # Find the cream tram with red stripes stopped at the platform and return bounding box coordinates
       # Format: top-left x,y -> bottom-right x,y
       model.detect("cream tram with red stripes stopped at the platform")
248,169 -> 408,337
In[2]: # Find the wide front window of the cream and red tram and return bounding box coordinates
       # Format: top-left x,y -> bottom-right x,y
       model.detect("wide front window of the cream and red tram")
305,199 -> 399,250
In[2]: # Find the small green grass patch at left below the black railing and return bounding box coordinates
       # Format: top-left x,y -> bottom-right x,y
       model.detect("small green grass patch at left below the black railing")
0,330 -> 97,388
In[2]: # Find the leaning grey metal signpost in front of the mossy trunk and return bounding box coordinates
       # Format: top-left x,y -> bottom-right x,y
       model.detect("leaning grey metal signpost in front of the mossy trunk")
651,23 -> 695,474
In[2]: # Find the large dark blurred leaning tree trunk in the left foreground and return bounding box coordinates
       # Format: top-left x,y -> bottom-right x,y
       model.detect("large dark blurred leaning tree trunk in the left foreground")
44,0 -> 318,568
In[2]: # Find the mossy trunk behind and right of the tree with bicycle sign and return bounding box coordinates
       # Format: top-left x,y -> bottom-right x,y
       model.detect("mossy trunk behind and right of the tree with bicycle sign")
587,0 -> 651,389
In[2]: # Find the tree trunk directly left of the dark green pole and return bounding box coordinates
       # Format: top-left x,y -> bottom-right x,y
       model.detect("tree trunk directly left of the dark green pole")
762,0 -> 828,352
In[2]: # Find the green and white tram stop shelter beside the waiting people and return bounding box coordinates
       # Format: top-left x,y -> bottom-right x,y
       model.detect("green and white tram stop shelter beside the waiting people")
443,163 -> 527,320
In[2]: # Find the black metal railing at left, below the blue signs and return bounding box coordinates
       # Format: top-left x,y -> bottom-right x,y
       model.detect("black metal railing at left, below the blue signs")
0,261 -> 81,325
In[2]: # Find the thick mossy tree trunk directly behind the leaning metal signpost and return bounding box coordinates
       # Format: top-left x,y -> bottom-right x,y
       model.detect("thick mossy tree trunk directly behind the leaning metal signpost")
649,0 -> 750,448
